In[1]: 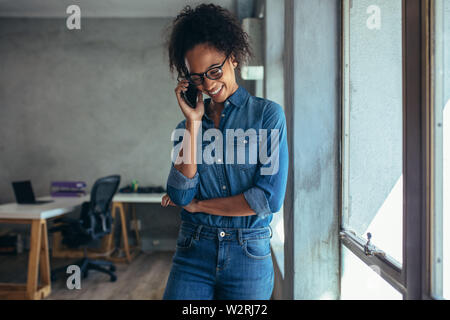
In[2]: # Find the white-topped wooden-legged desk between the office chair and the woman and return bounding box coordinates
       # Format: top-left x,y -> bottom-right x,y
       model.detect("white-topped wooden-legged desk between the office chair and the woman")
106,193 -> 165,263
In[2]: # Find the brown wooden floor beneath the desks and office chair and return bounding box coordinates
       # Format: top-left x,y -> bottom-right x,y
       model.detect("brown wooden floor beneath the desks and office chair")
0,252 -> 174,300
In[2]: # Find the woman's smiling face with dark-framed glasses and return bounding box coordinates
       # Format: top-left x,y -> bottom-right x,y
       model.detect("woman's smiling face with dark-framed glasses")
185,44 -> 238,103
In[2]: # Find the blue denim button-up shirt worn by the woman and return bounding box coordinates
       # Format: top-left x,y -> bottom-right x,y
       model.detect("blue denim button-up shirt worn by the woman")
167,86 -> 289,228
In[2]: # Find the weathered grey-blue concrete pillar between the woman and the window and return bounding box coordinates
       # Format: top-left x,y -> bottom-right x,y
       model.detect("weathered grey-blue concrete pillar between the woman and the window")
281,0 -> 341,299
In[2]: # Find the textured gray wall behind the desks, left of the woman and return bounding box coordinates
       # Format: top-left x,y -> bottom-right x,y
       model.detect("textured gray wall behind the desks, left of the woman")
0,18 -> 183,245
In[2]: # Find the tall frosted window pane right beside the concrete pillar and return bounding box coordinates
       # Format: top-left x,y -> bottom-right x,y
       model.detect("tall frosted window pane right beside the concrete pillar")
341,0 -> 403,299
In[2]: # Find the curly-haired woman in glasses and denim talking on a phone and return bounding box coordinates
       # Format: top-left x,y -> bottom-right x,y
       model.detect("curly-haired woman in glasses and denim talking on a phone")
161,4 -> 288,300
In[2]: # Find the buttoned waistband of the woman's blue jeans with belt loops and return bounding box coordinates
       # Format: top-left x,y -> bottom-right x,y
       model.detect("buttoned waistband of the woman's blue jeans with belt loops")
180,221 -> 272,243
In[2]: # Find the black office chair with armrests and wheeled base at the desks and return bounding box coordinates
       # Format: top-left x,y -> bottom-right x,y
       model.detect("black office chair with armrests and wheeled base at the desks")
49,175 -> 120,281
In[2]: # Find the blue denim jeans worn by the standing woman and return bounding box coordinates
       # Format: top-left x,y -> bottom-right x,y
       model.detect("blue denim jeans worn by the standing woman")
163,222 -> 274,300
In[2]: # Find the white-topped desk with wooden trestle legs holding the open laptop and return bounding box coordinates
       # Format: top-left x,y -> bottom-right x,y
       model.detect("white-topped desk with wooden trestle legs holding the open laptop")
0,196 -> 89,300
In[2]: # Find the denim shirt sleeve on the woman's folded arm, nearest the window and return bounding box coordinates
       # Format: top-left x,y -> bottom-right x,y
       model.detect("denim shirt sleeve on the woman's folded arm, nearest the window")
244,103 -> 289,218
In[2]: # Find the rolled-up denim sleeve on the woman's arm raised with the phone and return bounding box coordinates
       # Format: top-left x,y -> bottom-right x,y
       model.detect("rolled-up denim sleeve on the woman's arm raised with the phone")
167,120 -> 199,207
